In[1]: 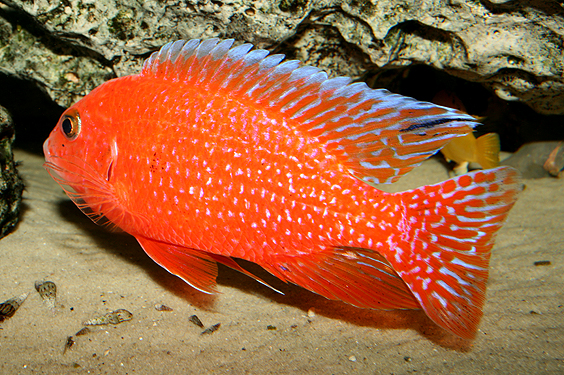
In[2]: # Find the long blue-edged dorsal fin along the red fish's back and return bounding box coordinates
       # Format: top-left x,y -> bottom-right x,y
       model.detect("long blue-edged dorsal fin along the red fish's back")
141,39 -> 478,183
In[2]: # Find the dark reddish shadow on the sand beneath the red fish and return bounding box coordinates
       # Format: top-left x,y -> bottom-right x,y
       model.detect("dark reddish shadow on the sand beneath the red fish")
58,200 -> 472,352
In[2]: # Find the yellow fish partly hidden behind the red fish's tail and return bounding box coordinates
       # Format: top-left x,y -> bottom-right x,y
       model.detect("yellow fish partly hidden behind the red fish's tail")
433,90 -> 500,175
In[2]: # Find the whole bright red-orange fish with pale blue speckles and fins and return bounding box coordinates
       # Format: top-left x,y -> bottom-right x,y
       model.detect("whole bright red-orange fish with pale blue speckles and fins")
44,39 -> 521,338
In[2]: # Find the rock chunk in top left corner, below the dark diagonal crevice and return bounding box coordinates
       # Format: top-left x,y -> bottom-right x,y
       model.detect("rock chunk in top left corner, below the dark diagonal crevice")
0,2 -> 116,107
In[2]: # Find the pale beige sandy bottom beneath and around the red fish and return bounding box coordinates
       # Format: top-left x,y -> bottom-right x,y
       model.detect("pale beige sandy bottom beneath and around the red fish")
0,151 -> 564,374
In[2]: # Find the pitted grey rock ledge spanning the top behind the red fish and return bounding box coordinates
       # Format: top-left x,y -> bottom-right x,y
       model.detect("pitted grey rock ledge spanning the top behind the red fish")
0,0 -> 564,114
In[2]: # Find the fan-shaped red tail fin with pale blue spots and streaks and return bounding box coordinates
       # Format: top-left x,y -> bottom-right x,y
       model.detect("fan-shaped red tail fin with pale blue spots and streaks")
388,167 -> 522,338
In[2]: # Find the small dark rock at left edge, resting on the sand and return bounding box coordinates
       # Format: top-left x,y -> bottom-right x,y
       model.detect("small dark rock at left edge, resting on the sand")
0,107 -> 24,238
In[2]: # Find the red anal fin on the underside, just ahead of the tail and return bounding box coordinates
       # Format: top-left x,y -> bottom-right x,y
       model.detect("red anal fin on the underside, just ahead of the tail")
262,247 -> 420,310
